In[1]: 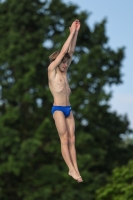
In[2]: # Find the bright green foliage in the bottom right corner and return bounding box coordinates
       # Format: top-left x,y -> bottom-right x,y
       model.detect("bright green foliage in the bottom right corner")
96,160 -> 133,200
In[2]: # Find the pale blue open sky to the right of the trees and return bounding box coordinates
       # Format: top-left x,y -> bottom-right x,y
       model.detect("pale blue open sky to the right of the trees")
63,0 -> 133,129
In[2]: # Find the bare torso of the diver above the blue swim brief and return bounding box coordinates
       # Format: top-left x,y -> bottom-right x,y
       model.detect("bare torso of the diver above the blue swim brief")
48,68 -> 71,106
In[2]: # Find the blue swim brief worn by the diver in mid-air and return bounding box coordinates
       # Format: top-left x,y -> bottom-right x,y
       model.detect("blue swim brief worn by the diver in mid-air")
52,106 -> 72,117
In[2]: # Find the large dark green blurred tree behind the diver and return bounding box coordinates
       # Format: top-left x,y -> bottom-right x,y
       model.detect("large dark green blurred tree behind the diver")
0,0 -> 133,200
